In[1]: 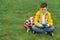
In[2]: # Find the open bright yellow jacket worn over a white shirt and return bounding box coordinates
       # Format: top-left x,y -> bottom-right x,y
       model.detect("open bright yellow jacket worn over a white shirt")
34,10 -> 53,27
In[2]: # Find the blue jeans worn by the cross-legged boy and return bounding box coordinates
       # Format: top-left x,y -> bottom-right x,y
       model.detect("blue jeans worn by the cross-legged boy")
32,24 -> 55,34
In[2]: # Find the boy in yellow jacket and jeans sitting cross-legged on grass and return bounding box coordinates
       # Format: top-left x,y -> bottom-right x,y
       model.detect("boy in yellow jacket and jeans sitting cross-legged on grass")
32,3 -> 54,36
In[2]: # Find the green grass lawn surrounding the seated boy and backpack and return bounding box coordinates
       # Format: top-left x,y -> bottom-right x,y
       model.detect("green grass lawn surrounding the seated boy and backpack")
0,0 -> 60,40
